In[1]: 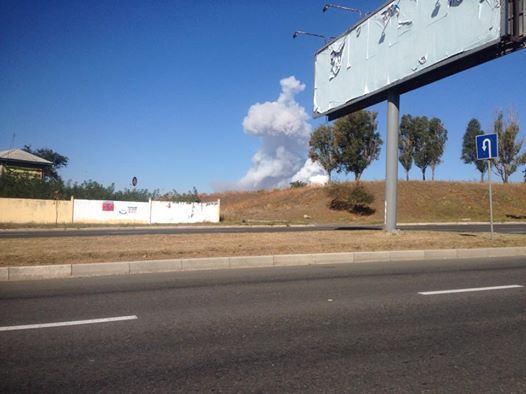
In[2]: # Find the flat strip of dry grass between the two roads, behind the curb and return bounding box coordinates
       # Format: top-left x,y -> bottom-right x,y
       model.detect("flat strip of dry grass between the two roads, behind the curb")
0,230 -> 526,266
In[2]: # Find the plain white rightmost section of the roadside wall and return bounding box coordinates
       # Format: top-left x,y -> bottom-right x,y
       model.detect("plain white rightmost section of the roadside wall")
151,201 -> 219,223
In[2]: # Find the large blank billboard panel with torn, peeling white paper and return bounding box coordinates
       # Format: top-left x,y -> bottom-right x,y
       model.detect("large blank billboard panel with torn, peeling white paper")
313,0 -> 524,119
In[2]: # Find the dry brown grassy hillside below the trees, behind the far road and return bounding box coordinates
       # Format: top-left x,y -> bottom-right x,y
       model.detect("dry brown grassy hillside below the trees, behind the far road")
207,181 -> 526,224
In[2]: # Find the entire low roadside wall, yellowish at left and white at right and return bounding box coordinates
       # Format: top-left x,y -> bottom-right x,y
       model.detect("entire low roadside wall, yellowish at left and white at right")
0,198 -> 220,224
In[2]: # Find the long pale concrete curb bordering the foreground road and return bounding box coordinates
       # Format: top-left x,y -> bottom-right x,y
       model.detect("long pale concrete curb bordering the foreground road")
0,246 -> 526,282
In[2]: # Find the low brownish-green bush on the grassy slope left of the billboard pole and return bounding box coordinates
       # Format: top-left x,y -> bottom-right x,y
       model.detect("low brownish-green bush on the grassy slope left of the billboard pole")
327,183 -> 375,215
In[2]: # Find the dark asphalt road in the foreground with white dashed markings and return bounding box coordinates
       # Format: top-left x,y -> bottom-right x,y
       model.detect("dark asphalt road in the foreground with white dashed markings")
0,258 -> 526,393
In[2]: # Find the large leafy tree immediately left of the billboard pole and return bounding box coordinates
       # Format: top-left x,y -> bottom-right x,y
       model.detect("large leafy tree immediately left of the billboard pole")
334,110 -> 383,181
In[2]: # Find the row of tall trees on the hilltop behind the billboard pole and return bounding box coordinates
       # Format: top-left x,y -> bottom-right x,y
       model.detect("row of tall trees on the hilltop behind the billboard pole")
309,110 -> 526,183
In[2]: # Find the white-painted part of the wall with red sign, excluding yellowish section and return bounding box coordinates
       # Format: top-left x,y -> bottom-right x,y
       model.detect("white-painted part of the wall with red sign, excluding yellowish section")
73,200 -> 220,224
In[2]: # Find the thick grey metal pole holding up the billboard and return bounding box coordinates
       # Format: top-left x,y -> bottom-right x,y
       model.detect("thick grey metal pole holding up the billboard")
384,90 -> 400,232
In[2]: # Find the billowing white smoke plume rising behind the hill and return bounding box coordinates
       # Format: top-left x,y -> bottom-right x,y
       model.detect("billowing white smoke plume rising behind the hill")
237,76 -> 327,190
